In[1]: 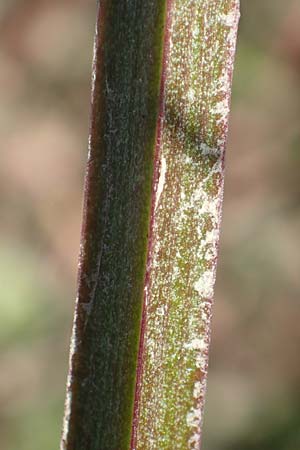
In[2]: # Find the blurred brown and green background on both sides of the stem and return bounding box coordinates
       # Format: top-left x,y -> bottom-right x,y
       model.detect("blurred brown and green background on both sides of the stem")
0,0 -> 300,450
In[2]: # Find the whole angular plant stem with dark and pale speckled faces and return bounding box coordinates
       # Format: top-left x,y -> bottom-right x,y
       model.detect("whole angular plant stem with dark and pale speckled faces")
61,0 -> 239,450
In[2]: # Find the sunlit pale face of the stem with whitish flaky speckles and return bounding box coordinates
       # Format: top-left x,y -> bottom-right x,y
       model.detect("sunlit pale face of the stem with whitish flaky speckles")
131,0 -> 239,450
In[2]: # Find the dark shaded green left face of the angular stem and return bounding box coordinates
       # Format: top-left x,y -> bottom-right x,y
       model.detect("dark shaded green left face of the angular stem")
61,0 -> 165,450
